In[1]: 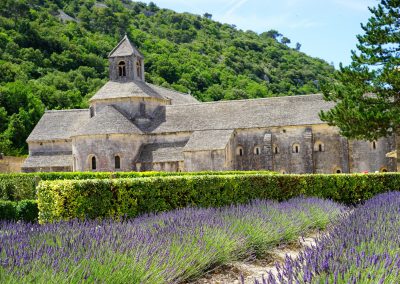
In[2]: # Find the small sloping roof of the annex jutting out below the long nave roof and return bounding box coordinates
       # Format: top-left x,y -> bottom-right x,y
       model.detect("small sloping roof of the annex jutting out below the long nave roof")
183,129 -> 233,151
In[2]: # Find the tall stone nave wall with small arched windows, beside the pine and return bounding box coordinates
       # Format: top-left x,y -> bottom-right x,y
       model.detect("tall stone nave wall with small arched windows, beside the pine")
230,125 -> 395,173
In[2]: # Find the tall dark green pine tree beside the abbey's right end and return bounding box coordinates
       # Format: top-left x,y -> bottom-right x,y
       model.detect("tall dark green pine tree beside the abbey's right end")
320,0 -> 400,165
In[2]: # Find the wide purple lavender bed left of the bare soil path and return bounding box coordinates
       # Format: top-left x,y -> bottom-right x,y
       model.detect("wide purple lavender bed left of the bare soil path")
0,198 -> 345,283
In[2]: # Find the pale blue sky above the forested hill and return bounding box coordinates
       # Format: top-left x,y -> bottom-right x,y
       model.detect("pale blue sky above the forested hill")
142,0 -> 379,67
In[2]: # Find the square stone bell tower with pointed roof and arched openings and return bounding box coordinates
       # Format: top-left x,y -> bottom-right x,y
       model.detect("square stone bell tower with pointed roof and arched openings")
108,35 -> 144,82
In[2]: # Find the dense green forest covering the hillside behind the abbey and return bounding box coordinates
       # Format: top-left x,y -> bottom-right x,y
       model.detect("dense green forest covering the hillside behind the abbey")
0,0 -> 334,155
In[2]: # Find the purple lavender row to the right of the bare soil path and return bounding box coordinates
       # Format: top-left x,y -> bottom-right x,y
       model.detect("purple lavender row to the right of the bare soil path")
255,192 -> 400,284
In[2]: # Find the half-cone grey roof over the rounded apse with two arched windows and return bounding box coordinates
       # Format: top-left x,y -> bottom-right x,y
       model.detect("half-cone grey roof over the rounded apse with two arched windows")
74,106 -> 142,136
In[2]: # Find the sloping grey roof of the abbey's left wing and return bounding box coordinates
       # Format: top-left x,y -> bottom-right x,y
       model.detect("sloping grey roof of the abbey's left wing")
27,109 -> 90,142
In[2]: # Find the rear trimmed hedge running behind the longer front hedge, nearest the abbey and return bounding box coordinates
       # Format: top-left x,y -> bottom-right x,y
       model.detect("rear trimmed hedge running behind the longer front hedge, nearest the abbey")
0,171 -> 273,201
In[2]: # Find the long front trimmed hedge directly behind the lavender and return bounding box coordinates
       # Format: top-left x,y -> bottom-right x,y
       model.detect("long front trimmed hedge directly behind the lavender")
38,174 -> 400,223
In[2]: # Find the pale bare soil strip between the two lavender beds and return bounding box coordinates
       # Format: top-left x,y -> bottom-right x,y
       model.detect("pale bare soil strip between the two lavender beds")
188,232 -> 323,284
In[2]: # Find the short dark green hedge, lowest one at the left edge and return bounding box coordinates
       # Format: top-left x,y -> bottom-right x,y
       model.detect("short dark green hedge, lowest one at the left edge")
0,200 -> 39,222
